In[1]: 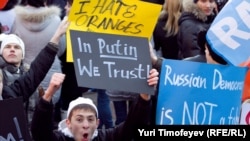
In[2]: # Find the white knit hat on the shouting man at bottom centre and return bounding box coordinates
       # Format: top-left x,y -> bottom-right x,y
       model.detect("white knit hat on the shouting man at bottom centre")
67,97 -> 98,118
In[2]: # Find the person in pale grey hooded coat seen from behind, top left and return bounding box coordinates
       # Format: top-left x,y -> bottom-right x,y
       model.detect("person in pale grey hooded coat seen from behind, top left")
11,0 -> 66,126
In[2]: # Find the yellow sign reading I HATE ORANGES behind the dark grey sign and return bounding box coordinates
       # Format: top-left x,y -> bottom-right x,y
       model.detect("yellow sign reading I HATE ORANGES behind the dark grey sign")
67,0 -> 161,62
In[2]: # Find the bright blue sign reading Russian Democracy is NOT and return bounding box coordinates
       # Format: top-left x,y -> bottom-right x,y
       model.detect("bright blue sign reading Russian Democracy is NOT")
156,60 -> 247,125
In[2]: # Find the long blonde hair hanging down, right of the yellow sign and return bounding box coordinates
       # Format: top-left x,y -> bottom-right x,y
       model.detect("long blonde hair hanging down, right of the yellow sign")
160,0 -> 183,37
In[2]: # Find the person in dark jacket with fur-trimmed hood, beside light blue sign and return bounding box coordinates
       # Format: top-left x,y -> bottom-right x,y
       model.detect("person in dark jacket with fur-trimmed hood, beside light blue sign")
177,0 -> 216,59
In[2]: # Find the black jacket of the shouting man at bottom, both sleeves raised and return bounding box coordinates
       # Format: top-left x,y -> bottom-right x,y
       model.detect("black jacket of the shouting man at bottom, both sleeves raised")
31,96 -> 151,141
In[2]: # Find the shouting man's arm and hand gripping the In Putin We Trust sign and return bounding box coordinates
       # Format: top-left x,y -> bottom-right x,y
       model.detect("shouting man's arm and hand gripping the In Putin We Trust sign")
111,69 -> 159,141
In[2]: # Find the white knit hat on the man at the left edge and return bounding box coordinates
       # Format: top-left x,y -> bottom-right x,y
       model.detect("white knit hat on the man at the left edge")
0,34 -> 25,58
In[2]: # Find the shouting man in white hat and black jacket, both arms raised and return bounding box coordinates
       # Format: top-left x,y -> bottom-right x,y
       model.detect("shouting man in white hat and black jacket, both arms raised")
31,69 -> 159,141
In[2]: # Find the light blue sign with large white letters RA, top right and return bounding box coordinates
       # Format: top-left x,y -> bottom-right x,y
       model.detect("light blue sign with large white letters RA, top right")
207,0 -> 250,66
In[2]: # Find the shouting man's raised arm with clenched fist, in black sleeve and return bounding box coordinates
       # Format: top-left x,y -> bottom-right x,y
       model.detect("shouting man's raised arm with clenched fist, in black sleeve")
31,73 -> 65,141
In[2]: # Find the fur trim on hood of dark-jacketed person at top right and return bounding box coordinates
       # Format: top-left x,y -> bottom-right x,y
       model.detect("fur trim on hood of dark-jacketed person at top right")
183,0 -> 214,22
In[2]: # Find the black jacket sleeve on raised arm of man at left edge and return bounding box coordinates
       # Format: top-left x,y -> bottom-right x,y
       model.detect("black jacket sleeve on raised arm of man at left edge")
2,43 -> 58,102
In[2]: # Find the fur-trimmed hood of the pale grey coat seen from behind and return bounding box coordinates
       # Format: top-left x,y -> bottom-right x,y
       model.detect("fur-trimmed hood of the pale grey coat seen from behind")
14,5 -> 61,31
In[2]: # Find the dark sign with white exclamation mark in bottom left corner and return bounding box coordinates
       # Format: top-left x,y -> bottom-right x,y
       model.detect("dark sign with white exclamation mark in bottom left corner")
0,98 -> 31,141
